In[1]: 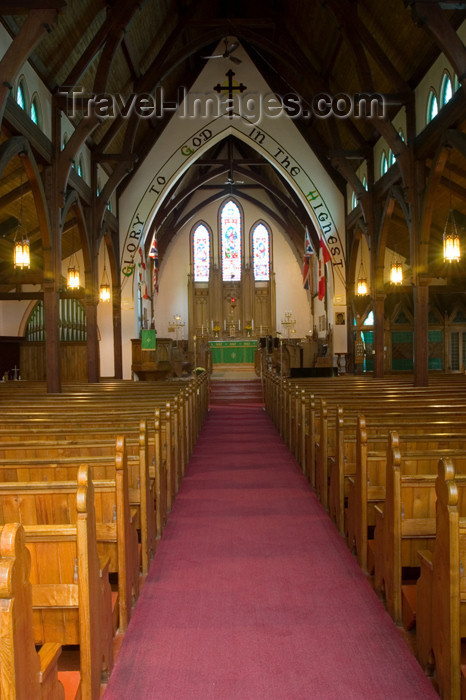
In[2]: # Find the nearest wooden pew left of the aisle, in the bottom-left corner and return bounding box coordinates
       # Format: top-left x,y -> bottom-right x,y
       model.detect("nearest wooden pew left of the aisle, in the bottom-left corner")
0,523 -> 65,700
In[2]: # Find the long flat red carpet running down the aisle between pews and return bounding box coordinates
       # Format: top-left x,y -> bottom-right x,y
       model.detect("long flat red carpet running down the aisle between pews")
104,406 -> 438,700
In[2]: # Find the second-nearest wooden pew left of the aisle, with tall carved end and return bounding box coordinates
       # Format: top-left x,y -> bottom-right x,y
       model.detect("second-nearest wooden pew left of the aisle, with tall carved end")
23,465 -> 113,700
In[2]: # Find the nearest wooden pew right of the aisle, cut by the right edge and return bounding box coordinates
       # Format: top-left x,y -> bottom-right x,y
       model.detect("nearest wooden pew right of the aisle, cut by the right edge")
416,458 -> 466,700
